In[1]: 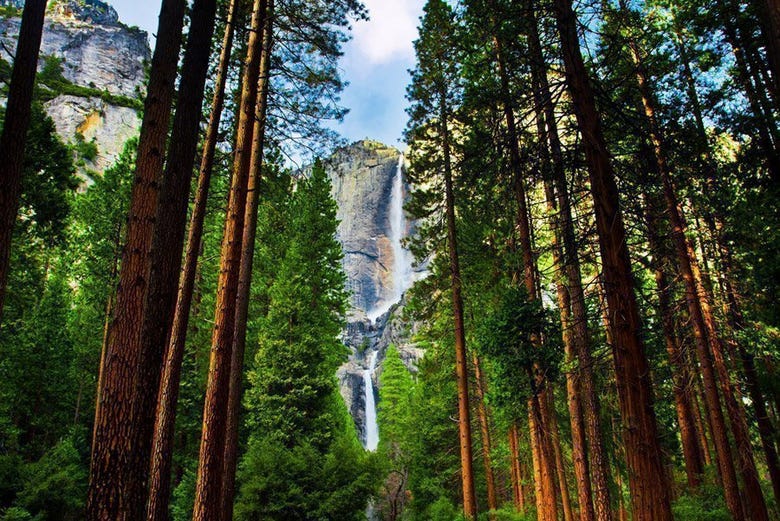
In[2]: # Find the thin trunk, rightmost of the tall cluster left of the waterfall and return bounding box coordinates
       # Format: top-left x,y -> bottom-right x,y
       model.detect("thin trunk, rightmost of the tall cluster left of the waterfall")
222,0 -> 274,520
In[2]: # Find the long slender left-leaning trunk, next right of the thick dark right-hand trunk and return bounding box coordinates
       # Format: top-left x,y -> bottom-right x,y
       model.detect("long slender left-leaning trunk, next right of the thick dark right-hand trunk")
623,26 -> 768,520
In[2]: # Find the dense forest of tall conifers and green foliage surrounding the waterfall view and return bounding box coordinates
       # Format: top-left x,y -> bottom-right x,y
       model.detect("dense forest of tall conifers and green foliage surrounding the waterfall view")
0,0 -> 780,521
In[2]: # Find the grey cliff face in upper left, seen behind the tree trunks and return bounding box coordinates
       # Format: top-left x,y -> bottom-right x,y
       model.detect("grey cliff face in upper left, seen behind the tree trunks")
0,0 -> 150,172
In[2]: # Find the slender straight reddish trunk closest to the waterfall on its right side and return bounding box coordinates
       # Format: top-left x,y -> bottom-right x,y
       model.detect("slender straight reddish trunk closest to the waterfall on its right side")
439,89 -> 477,520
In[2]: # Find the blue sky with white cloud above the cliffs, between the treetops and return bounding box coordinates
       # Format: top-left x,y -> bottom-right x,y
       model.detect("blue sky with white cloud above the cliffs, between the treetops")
109,0 -> 424,148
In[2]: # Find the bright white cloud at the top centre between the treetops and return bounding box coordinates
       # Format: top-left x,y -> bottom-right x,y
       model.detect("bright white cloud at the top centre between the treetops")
352,0 -> 423,65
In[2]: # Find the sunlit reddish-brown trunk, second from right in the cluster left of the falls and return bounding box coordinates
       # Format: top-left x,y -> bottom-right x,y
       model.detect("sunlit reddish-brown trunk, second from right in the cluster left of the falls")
193,0 -> 268,521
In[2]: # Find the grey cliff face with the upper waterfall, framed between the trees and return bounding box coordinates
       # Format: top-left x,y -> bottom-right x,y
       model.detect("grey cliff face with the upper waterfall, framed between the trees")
324,140 -> 425,439
